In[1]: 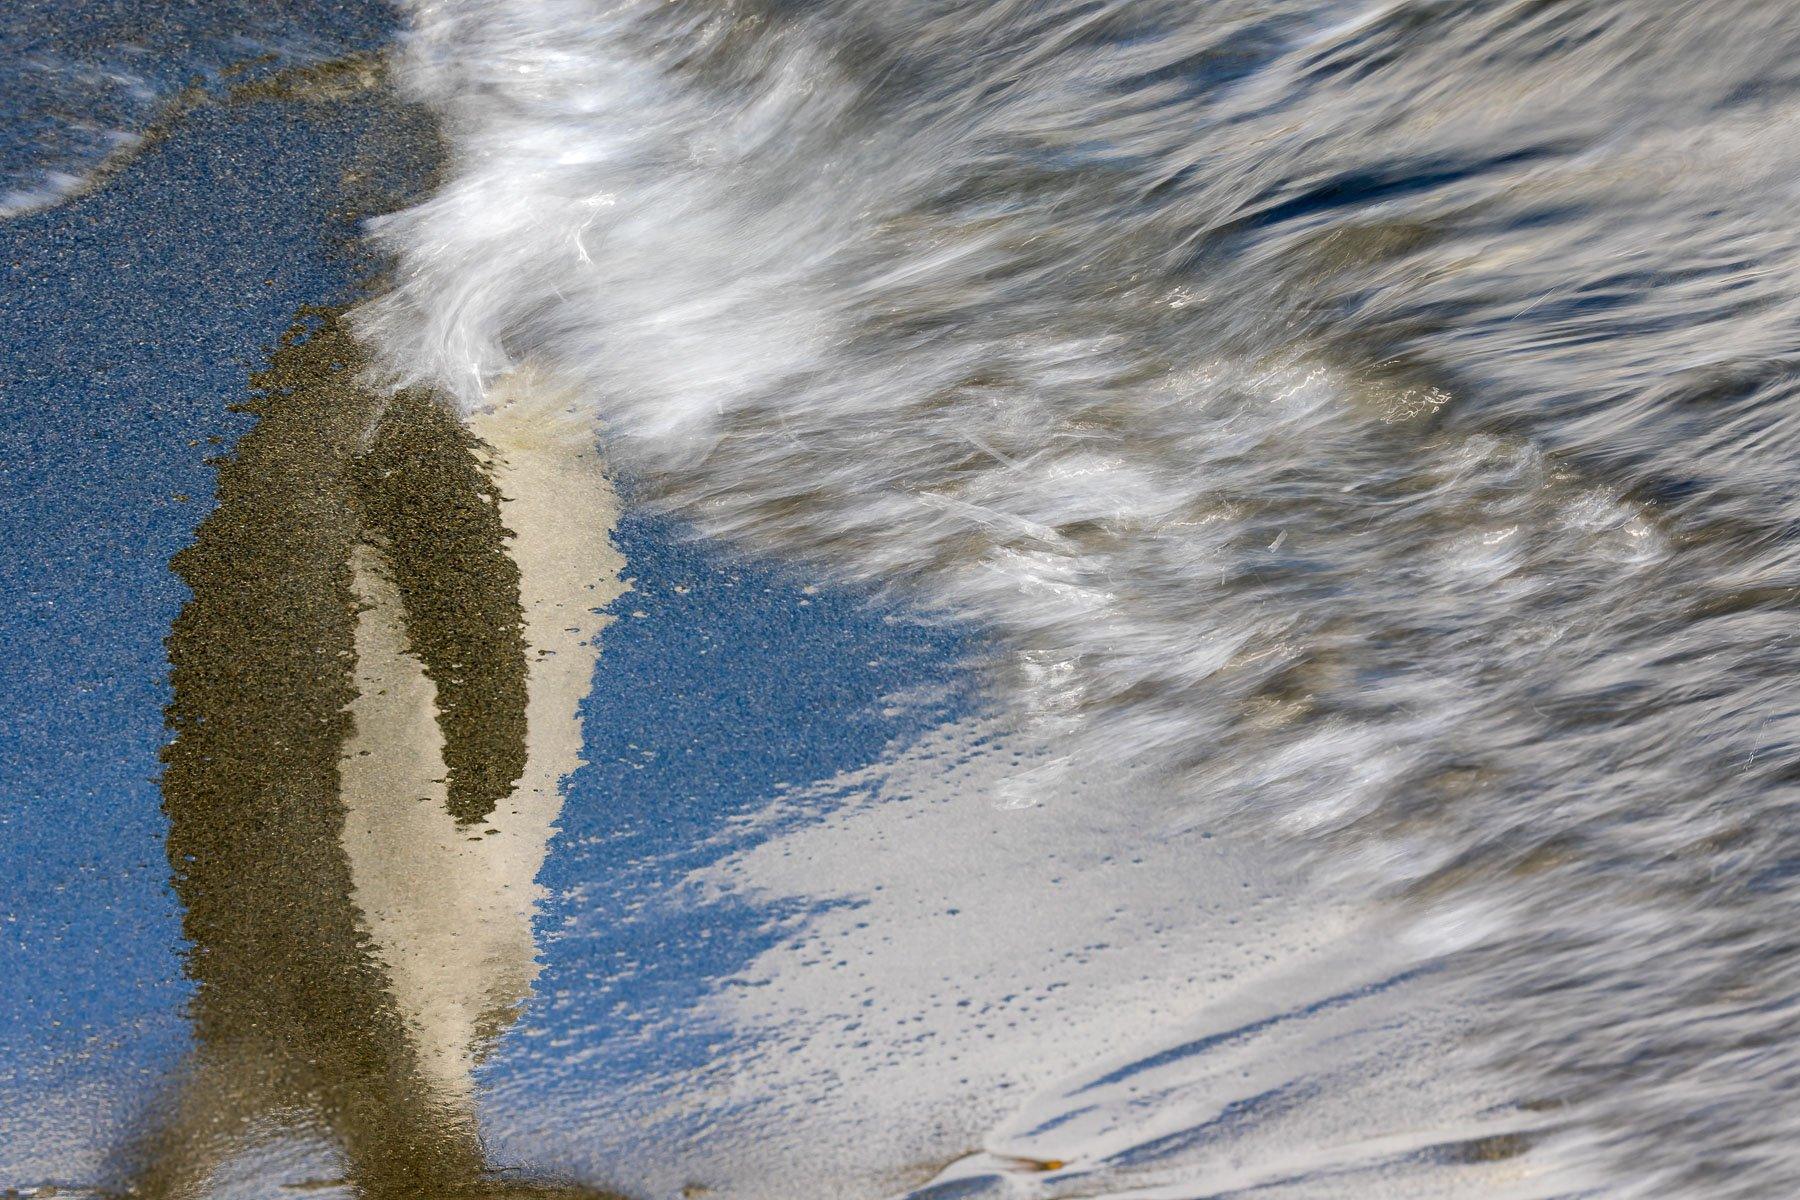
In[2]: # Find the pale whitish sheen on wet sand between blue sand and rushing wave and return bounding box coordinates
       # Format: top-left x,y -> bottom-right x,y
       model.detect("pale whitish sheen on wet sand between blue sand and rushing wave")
612,721 -> 1559,1200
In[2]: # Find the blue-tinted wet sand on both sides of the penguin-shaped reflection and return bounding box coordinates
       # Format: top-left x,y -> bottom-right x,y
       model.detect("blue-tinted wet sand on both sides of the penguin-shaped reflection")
0,4 -> 965,1187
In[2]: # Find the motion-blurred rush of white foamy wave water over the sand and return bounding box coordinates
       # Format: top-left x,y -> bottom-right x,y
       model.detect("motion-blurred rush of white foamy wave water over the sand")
362,0 -> 1800,1198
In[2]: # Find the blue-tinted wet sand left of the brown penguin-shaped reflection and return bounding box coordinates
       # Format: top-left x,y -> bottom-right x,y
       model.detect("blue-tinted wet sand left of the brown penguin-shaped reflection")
0,5 -> 423,1144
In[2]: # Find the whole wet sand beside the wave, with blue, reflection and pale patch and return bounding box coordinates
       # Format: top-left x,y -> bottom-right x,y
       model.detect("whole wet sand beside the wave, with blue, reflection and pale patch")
0,4 -> 1528,1200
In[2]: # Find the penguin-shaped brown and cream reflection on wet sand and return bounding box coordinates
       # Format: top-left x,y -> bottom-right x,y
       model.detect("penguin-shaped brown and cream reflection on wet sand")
119,311 -> 623,1200
